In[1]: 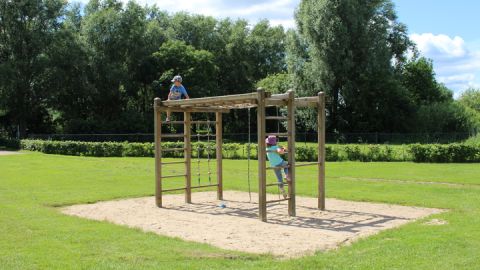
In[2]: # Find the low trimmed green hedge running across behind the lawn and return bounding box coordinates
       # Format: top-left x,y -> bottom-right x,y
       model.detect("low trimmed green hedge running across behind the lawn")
16,140 -> 480,162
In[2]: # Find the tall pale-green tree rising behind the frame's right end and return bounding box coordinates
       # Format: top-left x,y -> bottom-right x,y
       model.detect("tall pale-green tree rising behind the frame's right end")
288,0 -> 411,132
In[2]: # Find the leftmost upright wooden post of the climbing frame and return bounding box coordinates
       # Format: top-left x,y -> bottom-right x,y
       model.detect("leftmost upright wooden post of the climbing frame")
153,98 -> 162,207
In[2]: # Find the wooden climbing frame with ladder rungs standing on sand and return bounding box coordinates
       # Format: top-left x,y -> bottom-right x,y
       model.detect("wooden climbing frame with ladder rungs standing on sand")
154,88 -> 325,221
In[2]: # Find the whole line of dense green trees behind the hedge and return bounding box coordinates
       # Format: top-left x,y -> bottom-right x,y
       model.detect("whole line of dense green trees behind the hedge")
0,0 -> 480,136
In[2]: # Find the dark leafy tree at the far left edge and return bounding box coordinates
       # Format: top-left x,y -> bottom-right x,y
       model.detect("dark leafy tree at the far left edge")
0,0 -> 65,136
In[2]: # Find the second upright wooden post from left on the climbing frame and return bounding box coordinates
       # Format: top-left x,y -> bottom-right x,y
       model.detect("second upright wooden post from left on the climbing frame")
183,112 -> 192,203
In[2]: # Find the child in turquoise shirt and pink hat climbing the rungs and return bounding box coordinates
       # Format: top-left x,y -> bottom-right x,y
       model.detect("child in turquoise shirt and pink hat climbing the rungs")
265,136 -> 290,198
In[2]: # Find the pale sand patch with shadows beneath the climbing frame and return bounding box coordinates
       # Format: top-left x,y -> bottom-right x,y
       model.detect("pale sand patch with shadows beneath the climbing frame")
62,191 -> 442,257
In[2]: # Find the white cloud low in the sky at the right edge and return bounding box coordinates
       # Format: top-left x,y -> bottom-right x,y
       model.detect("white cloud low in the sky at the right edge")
410,33 -> 480,96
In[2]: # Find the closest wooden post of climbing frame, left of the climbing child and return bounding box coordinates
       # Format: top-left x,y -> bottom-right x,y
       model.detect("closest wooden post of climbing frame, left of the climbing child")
257,88 -> 267,221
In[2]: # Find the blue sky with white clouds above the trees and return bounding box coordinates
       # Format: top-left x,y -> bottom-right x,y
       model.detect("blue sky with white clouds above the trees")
77,0 -> 480,96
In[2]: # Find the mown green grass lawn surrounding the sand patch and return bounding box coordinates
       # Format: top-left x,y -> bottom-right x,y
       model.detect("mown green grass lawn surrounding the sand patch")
0,153 -> 480,269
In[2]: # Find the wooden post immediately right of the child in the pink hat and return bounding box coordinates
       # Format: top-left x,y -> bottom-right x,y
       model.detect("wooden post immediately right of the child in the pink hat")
287,90 -> 296,216
